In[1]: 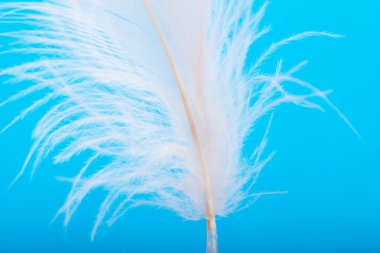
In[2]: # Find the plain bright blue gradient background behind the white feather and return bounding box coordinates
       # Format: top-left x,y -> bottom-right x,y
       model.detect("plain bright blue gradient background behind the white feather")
0,0 -> 380,253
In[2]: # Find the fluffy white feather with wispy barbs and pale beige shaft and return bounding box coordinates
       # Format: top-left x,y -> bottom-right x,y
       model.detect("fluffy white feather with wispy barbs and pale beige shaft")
0,0 -> 356,252
